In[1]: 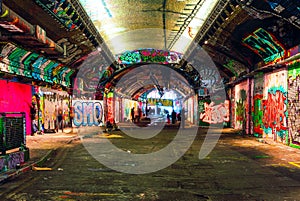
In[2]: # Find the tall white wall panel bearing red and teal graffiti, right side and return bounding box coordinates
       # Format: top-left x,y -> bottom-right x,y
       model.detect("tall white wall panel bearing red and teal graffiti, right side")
262,70 -> 288,143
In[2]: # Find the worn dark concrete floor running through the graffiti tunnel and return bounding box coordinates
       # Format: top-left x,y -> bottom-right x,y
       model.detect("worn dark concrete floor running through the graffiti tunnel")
0,128 -> 300,201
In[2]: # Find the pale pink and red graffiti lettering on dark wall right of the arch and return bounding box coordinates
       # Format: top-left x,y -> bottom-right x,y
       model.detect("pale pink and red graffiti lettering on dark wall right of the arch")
200,100 -> 229,124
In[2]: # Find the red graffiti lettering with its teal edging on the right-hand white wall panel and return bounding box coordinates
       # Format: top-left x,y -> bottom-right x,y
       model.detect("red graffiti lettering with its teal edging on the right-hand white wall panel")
263,88 -> 287,139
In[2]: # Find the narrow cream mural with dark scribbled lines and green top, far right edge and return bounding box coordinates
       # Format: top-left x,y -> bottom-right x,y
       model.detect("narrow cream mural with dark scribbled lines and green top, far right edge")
288,62 -> 300,145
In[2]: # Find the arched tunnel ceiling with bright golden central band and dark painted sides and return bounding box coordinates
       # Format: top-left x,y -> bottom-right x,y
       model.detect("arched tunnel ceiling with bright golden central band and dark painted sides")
0,0 -> 300,90
